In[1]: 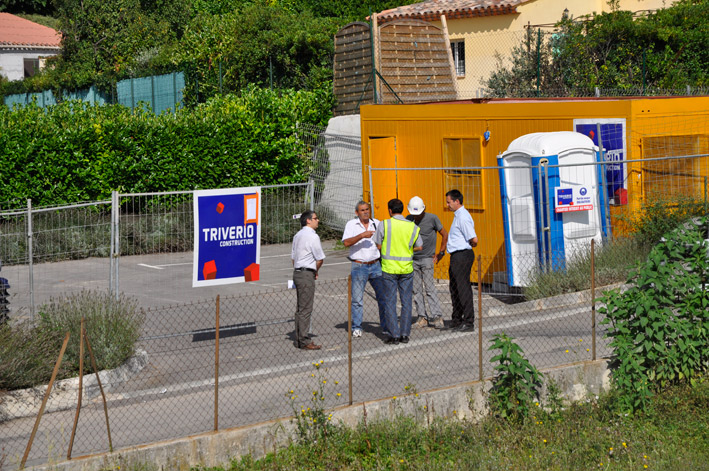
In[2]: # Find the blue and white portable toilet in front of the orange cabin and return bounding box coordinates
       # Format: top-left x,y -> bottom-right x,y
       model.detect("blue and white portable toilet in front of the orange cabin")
497,131 -> 609,287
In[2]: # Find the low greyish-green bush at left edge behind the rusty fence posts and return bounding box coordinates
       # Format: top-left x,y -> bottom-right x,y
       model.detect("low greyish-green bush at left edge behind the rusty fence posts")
0,291 -> 143,390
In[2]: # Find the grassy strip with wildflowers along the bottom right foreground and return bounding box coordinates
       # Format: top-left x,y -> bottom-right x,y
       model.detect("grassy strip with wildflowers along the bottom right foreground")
194,380 -> 709,471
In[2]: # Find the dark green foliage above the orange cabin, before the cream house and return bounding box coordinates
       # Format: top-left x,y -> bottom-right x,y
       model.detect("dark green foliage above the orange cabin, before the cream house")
486,0 -> 709,96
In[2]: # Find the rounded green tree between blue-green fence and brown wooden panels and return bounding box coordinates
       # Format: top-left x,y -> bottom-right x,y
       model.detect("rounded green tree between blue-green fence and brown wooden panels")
173,3 -> 337,98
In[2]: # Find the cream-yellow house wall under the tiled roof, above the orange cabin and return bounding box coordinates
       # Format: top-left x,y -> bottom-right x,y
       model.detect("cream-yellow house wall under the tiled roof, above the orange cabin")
426,0 -> 675,99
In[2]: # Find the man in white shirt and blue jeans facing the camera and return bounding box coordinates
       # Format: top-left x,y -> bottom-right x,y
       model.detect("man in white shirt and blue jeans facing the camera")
342,201 -> 389,338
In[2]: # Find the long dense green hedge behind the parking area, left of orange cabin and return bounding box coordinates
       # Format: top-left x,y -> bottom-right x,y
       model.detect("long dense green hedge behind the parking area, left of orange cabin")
0,87 -> 333,205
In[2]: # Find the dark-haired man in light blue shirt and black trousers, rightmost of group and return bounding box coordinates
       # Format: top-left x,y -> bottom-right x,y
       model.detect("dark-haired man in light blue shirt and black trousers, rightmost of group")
446,190 -> 478,332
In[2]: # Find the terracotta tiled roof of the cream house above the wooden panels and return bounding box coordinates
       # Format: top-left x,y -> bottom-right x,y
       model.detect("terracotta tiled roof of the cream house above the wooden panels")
377,0 -> 529,23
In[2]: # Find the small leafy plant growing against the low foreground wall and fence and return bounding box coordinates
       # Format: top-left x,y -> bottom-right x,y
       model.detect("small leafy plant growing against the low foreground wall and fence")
488,333 -> 542,421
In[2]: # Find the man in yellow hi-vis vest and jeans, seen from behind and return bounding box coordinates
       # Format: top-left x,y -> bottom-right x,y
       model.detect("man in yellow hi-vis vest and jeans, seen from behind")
373,199 -> 423,344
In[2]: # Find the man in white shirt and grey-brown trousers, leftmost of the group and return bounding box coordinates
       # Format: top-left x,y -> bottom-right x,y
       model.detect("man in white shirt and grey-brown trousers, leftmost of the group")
291,211 -> 325,350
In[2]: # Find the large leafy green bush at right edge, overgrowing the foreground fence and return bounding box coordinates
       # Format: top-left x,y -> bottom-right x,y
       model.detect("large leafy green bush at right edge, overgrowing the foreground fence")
599,218 -> 709,410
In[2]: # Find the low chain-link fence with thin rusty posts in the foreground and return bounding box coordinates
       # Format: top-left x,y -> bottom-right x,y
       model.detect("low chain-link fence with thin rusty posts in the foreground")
0,259 -> 607,467
